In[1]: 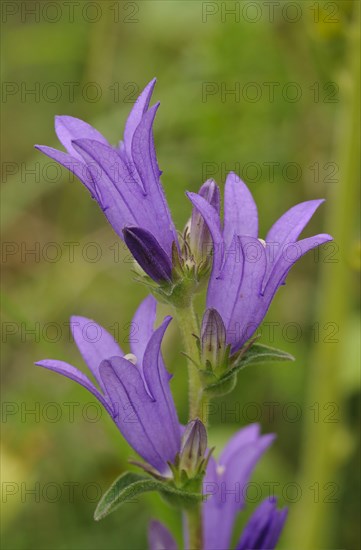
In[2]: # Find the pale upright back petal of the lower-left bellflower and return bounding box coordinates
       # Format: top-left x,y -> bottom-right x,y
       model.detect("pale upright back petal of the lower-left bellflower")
129,295 -> 157,365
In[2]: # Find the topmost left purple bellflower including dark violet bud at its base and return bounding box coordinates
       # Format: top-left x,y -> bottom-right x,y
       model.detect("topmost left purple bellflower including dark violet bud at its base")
36,79 -> 179,283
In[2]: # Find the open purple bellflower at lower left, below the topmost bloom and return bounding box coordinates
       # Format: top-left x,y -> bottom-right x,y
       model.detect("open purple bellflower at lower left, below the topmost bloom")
36,296 -> 181,476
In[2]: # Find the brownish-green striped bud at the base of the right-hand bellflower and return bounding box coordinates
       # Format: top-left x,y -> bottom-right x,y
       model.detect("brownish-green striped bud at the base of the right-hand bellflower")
201,308 -> 227,369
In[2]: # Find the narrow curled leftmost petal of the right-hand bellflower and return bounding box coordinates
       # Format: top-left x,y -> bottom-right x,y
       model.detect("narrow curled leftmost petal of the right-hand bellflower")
186,192 -> 223,276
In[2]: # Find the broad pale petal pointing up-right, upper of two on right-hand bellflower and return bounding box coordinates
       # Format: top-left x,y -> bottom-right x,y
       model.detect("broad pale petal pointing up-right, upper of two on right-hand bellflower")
264,199 -> 324,287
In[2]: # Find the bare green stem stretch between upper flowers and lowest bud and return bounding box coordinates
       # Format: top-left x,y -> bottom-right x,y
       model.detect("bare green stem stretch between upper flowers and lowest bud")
175,301 -> 208,425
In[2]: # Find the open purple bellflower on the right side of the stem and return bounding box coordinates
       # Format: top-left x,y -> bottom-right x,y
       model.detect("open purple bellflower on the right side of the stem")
187,173 -> 332,353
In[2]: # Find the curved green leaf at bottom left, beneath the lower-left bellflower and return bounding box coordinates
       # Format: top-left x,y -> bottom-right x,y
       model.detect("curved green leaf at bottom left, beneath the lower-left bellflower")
94,472 -> 203,521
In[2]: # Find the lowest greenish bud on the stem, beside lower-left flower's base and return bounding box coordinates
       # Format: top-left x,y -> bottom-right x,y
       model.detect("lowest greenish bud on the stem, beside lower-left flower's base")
179,418 -> 207,478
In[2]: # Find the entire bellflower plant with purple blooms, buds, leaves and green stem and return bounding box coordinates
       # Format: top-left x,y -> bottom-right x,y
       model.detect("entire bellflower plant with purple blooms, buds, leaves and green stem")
37,79 -> 331,550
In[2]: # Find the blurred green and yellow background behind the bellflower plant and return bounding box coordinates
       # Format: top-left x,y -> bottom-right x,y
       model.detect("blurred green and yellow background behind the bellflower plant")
1,0 -> 360,550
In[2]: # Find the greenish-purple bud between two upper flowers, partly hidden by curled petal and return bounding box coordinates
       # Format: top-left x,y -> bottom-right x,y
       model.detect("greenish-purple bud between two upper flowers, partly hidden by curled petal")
188,179 -> 220,262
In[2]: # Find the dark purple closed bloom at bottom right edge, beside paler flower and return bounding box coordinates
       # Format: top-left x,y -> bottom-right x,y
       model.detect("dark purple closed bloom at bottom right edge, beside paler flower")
236,498 -> 287,550
